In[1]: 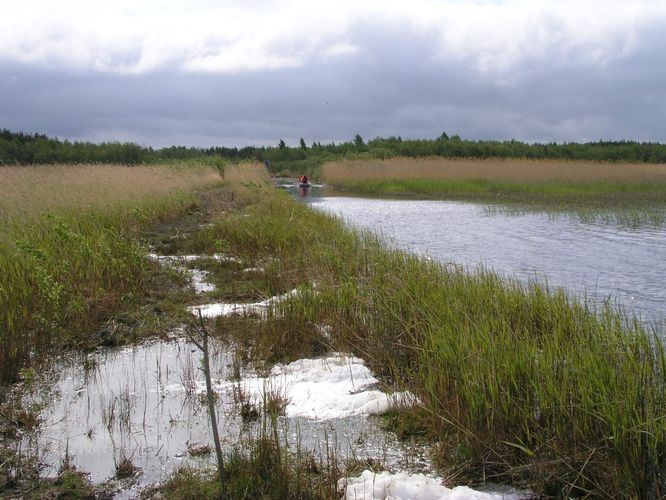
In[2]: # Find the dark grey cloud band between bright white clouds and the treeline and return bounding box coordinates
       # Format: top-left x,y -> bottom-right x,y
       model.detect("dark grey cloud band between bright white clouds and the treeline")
0,18 -> 666,146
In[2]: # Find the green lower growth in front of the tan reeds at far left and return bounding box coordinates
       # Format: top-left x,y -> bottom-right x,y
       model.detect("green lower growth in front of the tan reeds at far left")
0,207 -> 158,381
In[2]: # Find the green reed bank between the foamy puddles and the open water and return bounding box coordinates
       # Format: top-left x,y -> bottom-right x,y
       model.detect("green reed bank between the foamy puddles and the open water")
201,191 -> 666,498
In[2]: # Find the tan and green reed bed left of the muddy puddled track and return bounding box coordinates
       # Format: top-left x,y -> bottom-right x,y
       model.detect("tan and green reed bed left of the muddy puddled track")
0,165 -> 220,383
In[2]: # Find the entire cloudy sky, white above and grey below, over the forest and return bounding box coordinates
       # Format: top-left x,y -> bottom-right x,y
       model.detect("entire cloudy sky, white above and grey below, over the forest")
0,0 -> 666,147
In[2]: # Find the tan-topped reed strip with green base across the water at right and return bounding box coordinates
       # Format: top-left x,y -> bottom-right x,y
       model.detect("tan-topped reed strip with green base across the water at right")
322,158 -> 666,202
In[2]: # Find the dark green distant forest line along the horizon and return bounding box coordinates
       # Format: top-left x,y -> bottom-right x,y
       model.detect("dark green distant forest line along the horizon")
0,129 -> 666,171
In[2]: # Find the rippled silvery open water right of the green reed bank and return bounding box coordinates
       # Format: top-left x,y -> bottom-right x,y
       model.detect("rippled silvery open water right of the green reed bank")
286,187 -> 666,331
